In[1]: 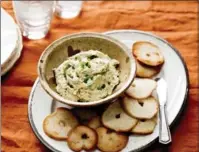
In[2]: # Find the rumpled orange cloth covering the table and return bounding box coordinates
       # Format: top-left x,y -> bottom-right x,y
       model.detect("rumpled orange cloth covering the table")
1,1 -> 199,152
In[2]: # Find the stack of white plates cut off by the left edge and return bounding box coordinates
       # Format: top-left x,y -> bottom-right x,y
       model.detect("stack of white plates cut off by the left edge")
1,8 -> 23,76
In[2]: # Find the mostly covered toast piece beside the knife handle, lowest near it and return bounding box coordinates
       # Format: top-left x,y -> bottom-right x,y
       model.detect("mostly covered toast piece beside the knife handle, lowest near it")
131,116 -> 157,135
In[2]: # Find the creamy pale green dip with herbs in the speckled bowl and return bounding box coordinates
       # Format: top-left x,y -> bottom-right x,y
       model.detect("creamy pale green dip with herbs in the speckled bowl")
55,50 -> 119,102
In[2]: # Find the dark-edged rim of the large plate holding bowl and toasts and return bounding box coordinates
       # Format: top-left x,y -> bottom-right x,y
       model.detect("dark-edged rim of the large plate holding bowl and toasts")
28,30 -> 190,152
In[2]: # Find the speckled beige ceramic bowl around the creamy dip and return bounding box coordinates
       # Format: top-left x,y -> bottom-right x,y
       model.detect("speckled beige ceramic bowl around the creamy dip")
38,33 -> 136,107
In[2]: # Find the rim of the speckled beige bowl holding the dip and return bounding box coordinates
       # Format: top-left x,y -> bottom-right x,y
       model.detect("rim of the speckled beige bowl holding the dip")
37,32 -> 136,107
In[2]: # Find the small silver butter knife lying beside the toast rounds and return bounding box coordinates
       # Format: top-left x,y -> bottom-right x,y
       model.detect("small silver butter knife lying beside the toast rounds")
155,78 -> 172,144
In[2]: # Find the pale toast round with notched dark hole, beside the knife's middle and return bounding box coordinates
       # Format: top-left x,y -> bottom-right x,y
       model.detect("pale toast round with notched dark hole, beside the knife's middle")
123,96 -> 159,119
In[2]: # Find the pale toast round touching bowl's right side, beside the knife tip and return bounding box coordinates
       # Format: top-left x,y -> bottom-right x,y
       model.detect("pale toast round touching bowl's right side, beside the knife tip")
126,78 -> 157,99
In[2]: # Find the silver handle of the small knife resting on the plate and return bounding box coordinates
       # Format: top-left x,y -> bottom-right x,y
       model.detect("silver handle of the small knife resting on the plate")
159,105 -> 171,144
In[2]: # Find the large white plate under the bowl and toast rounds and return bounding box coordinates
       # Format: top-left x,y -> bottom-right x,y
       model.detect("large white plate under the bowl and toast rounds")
28,30 -> 188,152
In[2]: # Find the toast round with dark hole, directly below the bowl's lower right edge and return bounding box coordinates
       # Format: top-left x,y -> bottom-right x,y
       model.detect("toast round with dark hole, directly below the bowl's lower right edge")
102,101 -> 137,132
